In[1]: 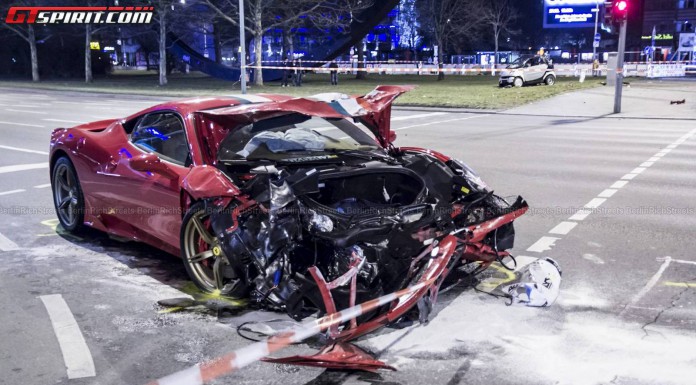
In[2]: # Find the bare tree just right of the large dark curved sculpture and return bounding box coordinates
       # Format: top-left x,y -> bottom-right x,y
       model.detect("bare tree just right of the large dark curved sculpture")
419,0 -> 483,80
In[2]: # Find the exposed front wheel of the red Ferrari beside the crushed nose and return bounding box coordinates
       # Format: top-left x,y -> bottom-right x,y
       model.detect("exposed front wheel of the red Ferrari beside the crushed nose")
180,202 -> 246,298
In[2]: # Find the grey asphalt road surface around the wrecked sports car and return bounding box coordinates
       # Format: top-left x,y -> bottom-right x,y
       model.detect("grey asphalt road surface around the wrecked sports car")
0,83 -> 696,385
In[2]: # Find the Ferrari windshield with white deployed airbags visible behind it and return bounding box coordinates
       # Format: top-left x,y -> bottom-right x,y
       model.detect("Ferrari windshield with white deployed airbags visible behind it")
218,113 -> 380,162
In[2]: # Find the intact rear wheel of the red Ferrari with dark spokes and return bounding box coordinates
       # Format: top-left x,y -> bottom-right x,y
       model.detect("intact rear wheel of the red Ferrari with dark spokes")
51,156 -> 85,234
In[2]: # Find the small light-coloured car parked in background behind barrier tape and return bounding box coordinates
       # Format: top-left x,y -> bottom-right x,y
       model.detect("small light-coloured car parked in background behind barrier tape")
498,55 -> 556,87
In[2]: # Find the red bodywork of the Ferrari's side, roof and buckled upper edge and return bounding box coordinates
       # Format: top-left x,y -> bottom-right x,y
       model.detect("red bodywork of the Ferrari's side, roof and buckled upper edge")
50,86 -> 412,255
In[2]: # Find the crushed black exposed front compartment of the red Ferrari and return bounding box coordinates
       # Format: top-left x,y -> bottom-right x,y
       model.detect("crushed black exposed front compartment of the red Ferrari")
201,149 -> 525,322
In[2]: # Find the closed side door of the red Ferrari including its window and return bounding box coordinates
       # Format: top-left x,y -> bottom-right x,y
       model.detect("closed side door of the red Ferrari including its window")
114,111 -> 191,249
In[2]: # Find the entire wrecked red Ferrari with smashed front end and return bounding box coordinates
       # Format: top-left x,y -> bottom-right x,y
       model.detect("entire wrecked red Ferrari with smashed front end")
50,86 -> 527,341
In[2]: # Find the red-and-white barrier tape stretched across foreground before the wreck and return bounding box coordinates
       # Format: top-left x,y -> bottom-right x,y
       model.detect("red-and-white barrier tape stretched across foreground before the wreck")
147,277 -> 437,385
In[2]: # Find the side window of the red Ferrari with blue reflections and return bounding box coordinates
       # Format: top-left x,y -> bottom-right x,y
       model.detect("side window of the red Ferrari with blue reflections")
130,112 -> 190,165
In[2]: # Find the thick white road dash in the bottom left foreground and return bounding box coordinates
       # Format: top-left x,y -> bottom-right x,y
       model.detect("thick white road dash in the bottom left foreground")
39,294 -> 97,379
